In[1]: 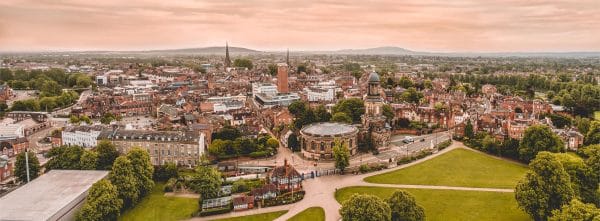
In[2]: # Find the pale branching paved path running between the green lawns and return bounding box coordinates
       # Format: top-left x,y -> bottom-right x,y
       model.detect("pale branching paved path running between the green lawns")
193,141 -> 513,221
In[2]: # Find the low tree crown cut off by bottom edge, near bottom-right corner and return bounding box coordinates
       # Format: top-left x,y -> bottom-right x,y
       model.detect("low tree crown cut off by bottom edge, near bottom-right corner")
548,199 -> 600,221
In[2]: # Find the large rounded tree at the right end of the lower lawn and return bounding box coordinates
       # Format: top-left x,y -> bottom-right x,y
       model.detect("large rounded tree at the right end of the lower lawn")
515,151 -> 574,221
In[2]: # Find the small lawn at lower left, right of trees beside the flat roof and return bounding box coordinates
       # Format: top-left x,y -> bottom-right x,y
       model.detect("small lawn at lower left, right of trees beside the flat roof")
119,183 -> 198,221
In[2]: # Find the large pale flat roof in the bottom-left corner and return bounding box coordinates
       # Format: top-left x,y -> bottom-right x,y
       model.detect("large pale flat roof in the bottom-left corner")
0,170 -> 108,220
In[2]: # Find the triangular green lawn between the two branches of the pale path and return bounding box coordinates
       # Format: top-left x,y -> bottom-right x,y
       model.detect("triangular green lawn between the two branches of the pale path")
365,149 -> 527,188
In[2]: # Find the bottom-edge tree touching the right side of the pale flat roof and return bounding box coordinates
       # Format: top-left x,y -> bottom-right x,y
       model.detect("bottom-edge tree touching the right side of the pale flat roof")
77,179 -> 123,221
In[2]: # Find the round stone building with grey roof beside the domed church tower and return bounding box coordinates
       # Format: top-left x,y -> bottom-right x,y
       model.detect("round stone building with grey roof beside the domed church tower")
300,122 -> 359,159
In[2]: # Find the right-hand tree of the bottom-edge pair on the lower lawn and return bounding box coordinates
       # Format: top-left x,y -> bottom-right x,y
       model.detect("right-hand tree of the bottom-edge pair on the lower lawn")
387,190 -> 425,221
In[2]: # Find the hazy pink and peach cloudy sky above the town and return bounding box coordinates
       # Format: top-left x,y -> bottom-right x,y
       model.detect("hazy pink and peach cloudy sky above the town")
0,0 -> 600,52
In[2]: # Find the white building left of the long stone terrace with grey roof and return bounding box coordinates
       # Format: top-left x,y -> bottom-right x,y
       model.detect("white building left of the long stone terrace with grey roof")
62,125 -> 105,148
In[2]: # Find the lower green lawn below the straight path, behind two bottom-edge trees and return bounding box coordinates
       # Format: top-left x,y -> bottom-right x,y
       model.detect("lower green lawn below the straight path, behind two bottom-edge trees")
335,187 -> 531,221
